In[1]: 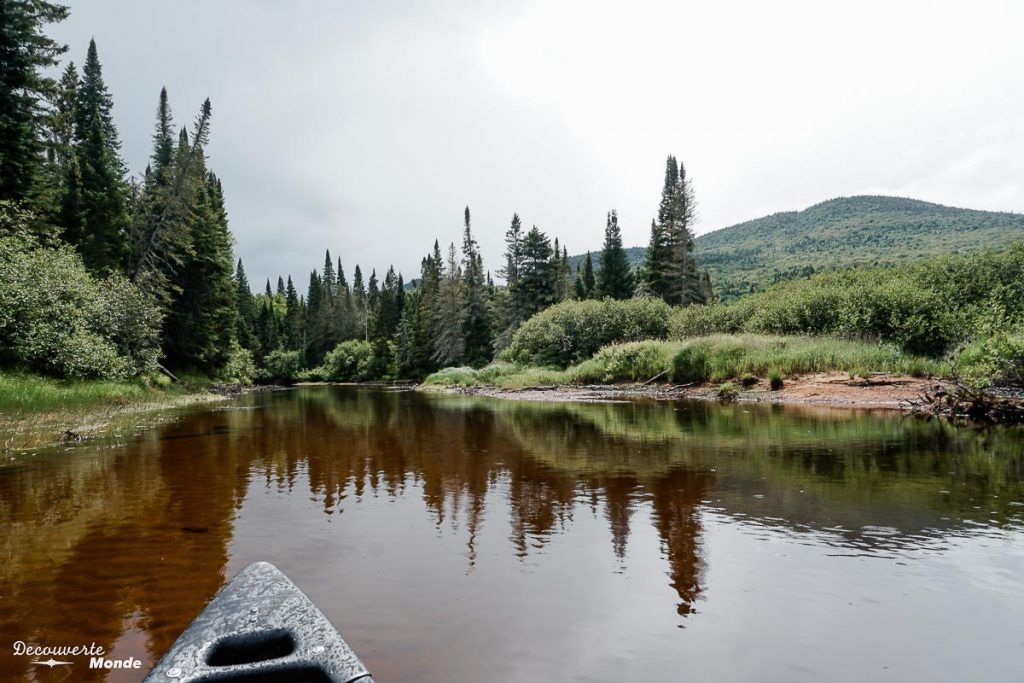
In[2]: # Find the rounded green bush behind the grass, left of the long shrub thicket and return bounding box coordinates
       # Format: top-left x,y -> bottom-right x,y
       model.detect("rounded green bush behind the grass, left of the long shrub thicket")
503,299 -> 670,368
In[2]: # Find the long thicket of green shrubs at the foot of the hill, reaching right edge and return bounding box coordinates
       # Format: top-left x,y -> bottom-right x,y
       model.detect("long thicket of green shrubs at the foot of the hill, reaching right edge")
671,244 -> 1024,356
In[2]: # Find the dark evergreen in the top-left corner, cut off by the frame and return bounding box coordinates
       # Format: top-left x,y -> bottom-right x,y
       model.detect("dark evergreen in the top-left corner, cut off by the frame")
0,0 -> 68,202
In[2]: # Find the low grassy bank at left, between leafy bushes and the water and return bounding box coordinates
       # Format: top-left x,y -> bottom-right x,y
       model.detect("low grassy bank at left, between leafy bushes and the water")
0,373 -> 224,452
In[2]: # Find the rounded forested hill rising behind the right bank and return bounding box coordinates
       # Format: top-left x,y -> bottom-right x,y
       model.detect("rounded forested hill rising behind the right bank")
570,192 -> 1024,299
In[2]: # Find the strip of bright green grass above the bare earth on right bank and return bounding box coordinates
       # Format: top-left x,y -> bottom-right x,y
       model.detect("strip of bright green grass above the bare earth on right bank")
424,335 -> 949,389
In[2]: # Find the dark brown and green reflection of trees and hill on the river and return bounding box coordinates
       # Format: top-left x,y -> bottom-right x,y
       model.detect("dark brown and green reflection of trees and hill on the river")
0,388 -> 1024,680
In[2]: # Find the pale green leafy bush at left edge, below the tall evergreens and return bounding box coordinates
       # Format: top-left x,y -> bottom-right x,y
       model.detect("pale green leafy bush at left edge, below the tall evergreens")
0,238 -> 161,379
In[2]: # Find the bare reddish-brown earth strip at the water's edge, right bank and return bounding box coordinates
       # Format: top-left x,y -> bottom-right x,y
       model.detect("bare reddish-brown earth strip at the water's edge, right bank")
418,373 -> 941,411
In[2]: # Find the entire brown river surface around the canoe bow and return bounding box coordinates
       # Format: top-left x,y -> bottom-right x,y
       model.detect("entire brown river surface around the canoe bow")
0,387 -> 1024,683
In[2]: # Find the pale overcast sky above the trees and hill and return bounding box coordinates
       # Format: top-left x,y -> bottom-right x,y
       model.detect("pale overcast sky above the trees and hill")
50,0 -> 1024,289
